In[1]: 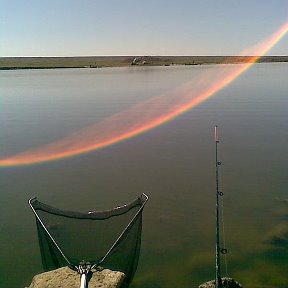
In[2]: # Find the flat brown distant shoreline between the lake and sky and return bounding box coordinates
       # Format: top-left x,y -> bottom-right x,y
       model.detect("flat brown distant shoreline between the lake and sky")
0,56 -> 288,70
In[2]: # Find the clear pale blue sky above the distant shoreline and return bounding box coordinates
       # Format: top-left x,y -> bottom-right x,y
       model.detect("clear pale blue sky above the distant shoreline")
0,0 -> 288,56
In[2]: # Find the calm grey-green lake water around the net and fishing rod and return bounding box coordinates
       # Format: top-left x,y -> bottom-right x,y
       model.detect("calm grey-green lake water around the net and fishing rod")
0,63 -> 288,288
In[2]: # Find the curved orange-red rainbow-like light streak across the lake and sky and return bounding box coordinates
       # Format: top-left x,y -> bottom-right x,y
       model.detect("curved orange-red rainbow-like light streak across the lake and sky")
0,21 -> 288,167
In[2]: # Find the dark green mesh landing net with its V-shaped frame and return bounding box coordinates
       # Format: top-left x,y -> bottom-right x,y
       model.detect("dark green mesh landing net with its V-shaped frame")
29,194 -> 148,287
